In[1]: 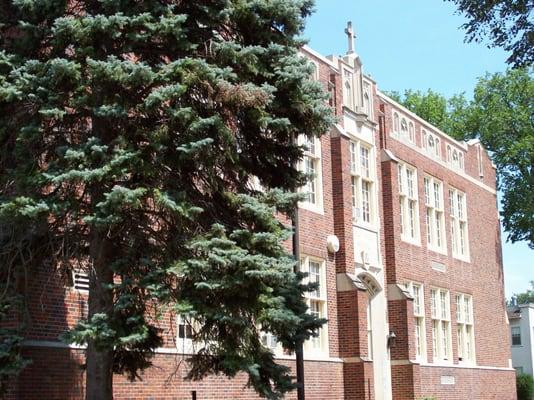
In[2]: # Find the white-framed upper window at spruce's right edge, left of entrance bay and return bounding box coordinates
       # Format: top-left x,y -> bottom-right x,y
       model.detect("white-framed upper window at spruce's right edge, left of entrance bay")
298,135 -> 324,214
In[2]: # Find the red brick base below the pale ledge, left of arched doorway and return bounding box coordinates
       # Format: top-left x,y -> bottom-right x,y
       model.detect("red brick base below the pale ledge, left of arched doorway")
7,348 -> 343,400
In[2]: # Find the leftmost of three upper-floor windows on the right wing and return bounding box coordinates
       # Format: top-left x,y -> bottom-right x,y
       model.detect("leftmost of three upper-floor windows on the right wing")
398,163 -> 419,242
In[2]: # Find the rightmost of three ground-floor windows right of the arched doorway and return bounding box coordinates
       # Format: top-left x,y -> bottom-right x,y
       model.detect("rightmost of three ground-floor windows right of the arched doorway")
456,294 -> 475,362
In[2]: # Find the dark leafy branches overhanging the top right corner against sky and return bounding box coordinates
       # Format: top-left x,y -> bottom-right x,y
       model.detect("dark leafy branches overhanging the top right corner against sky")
447,0 -> 534,68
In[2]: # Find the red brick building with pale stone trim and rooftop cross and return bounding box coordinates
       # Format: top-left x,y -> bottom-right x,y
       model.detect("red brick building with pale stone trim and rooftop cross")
8,27 -> 515,400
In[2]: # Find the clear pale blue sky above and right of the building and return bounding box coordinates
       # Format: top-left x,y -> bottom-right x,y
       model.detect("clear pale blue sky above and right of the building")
304,0 -> 534,297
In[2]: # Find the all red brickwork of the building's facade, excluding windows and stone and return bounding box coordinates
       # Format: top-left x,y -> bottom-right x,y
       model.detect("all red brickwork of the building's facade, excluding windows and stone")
4,50 -> 515,400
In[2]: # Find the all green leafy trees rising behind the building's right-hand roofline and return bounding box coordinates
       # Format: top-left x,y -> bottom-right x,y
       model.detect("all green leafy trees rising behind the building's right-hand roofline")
393,68 -> 534,248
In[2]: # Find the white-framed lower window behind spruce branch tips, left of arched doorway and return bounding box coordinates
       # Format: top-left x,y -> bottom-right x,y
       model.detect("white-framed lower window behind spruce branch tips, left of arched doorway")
300,255 -> 328,357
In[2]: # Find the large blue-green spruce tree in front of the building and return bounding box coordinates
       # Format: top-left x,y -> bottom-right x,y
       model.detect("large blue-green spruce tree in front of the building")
0,0 -> 331,399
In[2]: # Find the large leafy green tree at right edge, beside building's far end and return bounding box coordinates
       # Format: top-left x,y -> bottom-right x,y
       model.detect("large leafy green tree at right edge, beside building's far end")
473,69 -> 534,248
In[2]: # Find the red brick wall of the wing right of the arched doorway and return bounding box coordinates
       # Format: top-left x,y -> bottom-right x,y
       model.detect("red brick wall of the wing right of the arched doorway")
375,98 -> 515,399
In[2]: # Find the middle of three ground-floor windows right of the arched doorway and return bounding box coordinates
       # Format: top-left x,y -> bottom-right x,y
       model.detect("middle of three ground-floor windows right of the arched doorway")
430,289 -> 452,361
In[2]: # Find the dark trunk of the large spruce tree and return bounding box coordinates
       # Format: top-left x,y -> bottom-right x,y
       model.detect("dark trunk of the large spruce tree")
85,232 -> 113,400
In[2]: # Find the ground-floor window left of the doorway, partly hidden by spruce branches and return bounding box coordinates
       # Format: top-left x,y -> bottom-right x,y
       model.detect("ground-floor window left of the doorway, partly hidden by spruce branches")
300,256 -> 328,353
